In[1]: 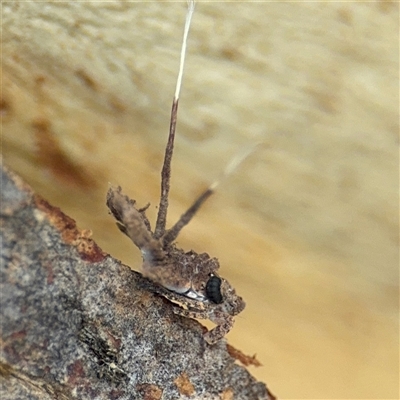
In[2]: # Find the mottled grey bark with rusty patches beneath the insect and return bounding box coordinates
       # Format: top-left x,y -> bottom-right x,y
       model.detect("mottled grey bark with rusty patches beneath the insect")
0,163 -> 273,400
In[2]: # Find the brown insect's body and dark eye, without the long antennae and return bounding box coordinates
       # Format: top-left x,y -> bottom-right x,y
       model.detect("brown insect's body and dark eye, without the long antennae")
107,188 -> 245,344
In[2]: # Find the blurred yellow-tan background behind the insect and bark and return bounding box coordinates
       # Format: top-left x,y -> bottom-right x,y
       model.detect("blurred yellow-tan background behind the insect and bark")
0,1 -> 399,399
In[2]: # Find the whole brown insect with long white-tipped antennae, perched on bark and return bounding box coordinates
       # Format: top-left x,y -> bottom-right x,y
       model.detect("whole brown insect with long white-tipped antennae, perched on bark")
107,0 -> 245,344
